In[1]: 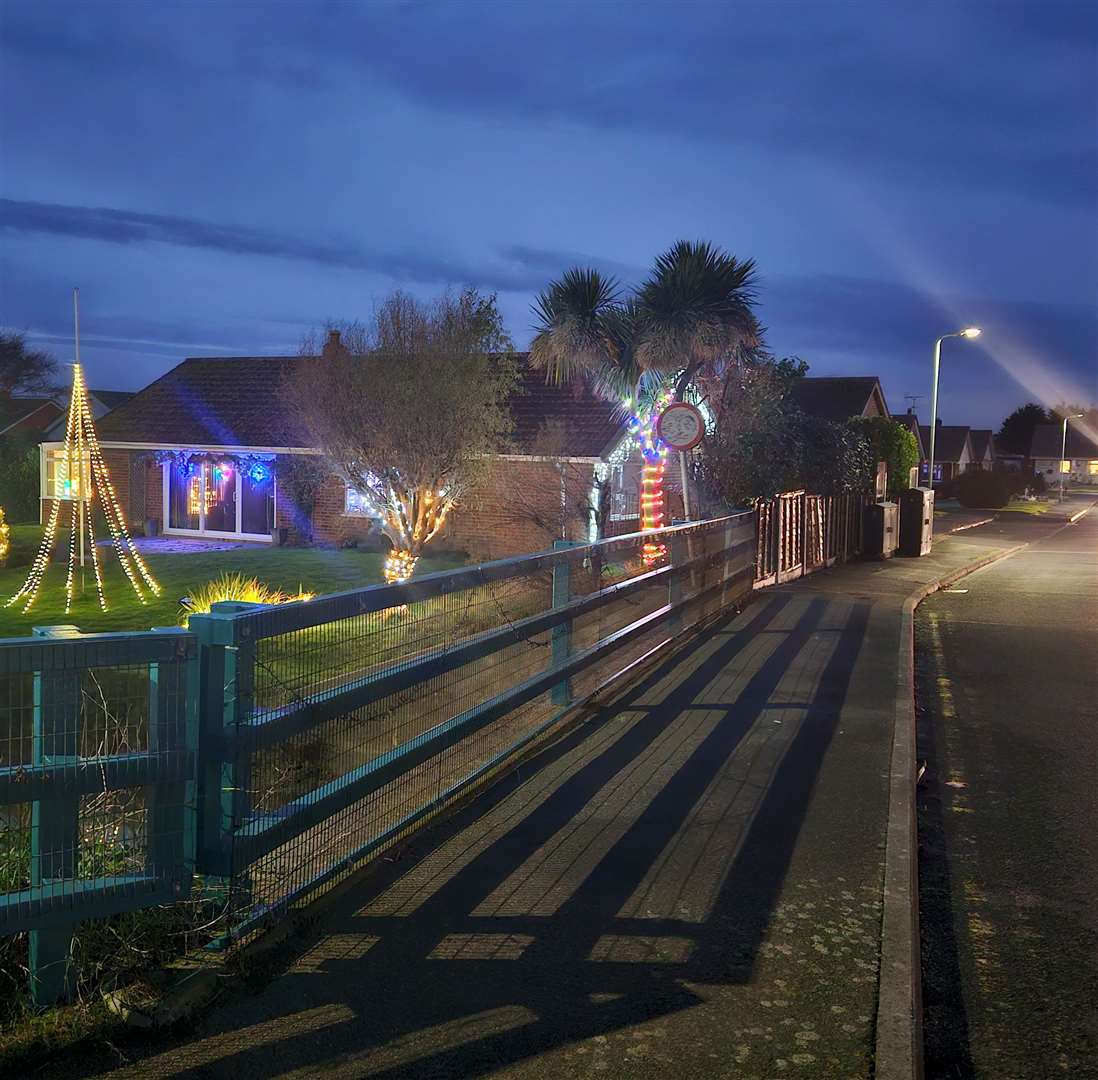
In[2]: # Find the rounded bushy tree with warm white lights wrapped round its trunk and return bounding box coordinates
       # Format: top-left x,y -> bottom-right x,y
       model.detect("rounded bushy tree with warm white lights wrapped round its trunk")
289,289 -> 517,582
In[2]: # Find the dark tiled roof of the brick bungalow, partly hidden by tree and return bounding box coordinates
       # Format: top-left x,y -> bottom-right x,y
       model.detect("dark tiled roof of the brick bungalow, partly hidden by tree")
97,353 -> 624,458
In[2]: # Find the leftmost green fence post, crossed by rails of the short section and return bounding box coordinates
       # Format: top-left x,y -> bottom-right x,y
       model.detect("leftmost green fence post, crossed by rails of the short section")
27,626 -> 80,1005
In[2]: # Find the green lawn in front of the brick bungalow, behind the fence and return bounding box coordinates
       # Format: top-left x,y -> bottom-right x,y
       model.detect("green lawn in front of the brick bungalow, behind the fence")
0,525 -> 461,638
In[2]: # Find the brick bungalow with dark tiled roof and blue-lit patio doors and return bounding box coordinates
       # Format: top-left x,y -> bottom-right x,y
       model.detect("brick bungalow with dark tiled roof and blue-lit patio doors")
42,351 -> 667,558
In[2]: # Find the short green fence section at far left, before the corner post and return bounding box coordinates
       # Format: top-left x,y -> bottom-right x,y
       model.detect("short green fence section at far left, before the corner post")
0,627 -> 199,1003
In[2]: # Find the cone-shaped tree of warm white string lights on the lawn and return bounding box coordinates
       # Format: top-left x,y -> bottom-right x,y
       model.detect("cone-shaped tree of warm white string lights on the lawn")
7,363 -> 160,615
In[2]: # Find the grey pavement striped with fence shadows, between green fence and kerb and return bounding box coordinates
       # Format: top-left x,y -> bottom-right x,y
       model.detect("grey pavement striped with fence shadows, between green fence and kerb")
49,515 -> 1062,1080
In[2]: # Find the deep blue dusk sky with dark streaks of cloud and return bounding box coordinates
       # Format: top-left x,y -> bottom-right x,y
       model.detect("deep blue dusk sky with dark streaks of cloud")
0,0 -> 1098,425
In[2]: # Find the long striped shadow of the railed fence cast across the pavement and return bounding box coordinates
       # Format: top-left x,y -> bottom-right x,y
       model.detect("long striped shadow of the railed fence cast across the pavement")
107,593 -> 870,1077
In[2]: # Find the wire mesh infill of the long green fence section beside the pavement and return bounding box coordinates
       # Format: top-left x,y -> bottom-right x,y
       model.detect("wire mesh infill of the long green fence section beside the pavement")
222,515 -> 754,927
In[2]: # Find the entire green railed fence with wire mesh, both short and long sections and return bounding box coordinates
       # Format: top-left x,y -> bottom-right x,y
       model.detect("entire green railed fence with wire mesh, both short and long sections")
0,513 -> 757,1002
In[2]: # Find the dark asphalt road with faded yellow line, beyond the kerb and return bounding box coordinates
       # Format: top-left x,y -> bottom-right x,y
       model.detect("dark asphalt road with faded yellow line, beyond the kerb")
916,509 -> 1098,1080
